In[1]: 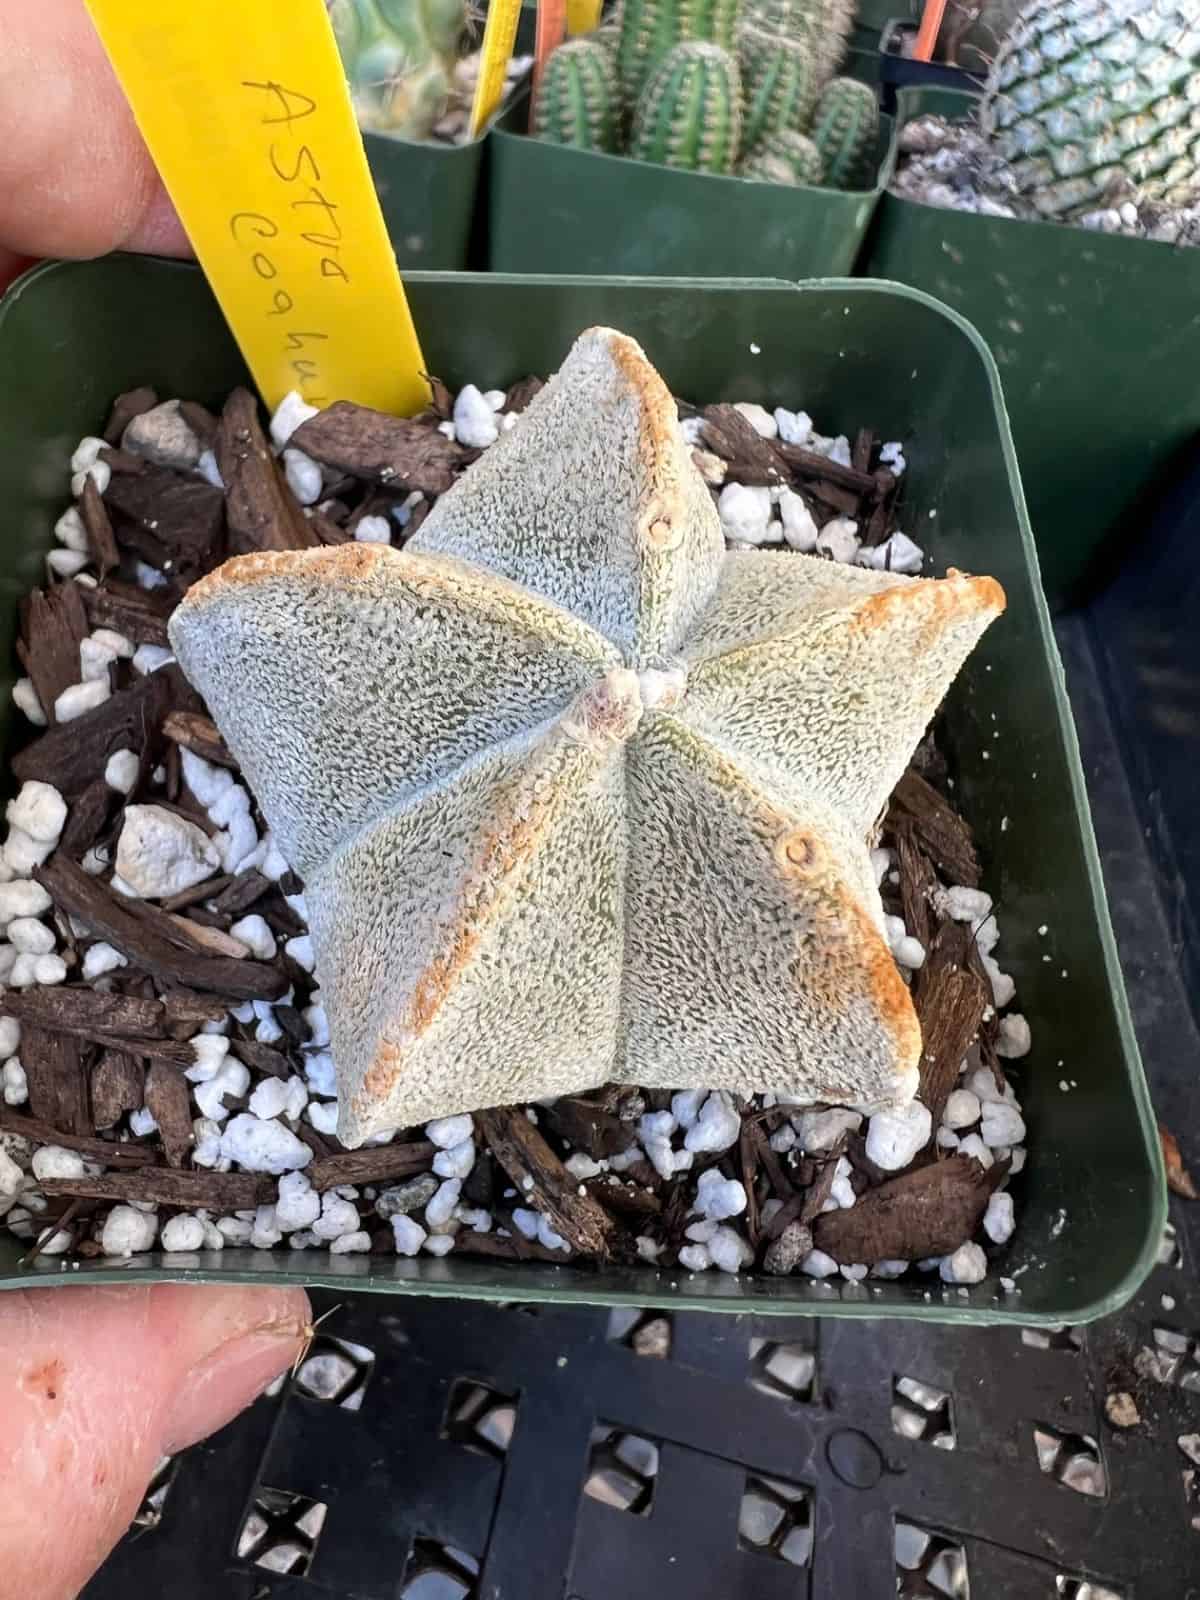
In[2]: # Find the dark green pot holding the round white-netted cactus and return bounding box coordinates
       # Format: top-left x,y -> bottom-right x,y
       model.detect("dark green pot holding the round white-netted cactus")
861,90 -> 1200,610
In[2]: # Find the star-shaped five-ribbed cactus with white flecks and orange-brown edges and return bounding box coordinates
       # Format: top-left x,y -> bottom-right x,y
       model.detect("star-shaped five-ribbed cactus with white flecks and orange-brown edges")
171,328 -> 1003,1146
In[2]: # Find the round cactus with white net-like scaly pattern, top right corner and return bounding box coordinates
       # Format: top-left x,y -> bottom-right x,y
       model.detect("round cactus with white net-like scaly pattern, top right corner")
979,0 -> 1200,218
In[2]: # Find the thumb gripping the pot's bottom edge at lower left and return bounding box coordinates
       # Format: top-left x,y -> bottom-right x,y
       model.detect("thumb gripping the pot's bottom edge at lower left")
0,1283 -> 309,1600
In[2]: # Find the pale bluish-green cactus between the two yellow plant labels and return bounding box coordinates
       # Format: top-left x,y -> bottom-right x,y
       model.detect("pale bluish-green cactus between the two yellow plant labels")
330,0 -> 467,139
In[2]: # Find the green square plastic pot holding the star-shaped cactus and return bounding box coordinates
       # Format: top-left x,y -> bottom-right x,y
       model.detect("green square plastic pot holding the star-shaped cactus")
0,258 -> 1165,1323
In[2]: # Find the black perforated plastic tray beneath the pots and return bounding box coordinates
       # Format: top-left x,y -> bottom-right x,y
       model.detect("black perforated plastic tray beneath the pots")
86,619 -> 1200,1600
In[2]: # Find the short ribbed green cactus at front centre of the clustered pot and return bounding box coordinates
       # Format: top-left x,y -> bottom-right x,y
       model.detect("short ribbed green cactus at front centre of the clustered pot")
629,40 -> 742,173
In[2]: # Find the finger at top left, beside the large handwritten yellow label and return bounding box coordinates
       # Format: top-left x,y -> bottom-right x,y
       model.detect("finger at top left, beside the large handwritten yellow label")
0,0 -> 190,288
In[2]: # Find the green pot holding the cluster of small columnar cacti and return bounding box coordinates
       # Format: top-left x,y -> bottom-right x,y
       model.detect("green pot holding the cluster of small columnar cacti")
488,87 -> 893,278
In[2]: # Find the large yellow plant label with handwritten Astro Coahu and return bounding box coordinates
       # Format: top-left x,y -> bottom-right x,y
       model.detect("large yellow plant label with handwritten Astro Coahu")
86,0 -> 429,414
